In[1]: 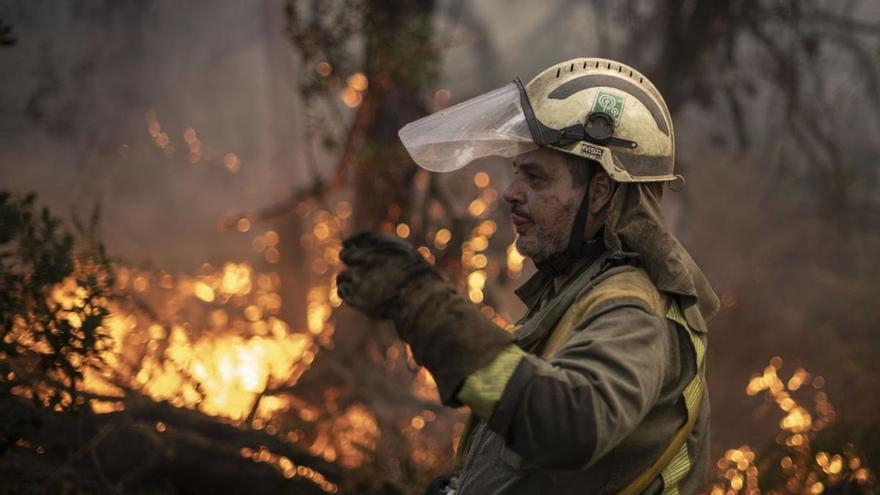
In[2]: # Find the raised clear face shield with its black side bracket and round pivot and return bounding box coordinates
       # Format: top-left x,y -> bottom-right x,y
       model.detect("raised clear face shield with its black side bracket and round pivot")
398,78 -> 636,172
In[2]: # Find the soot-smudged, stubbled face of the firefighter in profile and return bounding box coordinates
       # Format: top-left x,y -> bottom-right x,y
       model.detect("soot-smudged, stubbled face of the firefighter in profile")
503,148 -> 586,262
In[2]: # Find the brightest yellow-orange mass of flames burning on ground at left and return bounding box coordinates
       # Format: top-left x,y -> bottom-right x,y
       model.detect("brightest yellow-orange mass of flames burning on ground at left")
85,263 -> 314,421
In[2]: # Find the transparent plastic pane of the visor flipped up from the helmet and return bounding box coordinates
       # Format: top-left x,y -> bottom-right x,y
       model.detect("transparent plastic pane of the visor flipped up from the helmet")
398,83 -> 538,172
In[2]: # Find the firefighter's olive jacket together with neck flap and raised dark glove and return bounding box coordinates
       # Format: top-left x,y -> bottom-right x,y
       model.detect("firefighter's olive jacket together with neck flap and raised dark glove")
337,183 -> 718,495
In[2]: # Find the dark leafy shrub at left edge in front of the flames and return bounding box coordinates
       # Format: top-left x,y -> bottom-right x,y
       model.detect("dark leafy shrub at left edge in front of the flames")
0,192 -> 112,449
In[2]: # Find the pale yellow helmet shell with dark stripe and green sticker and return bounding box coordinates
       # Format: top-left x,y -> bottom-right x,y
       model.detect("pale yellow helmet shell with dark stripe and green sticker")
516,58 -> 676,182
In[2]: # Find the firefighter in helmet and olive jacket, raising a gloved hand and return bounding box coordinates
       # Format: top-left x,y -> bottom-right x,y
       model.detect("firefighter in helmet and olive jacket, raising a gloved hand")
337,58 -> 718,495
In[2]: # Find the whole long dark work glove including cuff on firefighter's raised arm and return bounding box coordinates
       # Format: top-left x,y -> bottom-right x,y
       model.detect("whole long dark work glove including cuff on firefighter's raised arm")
336,232 -> 514,406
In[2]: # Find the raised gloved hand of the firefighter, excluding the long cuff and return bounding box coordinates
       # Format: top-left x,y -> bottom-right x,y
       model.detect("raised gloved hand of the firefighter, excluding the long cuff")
336,232 -> 440,319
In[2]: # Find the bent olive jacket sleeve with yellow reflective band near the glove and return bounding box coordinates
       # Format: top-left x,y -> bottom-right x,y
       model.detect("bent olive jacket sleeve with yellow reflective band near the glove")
459,298 -> 673,469
